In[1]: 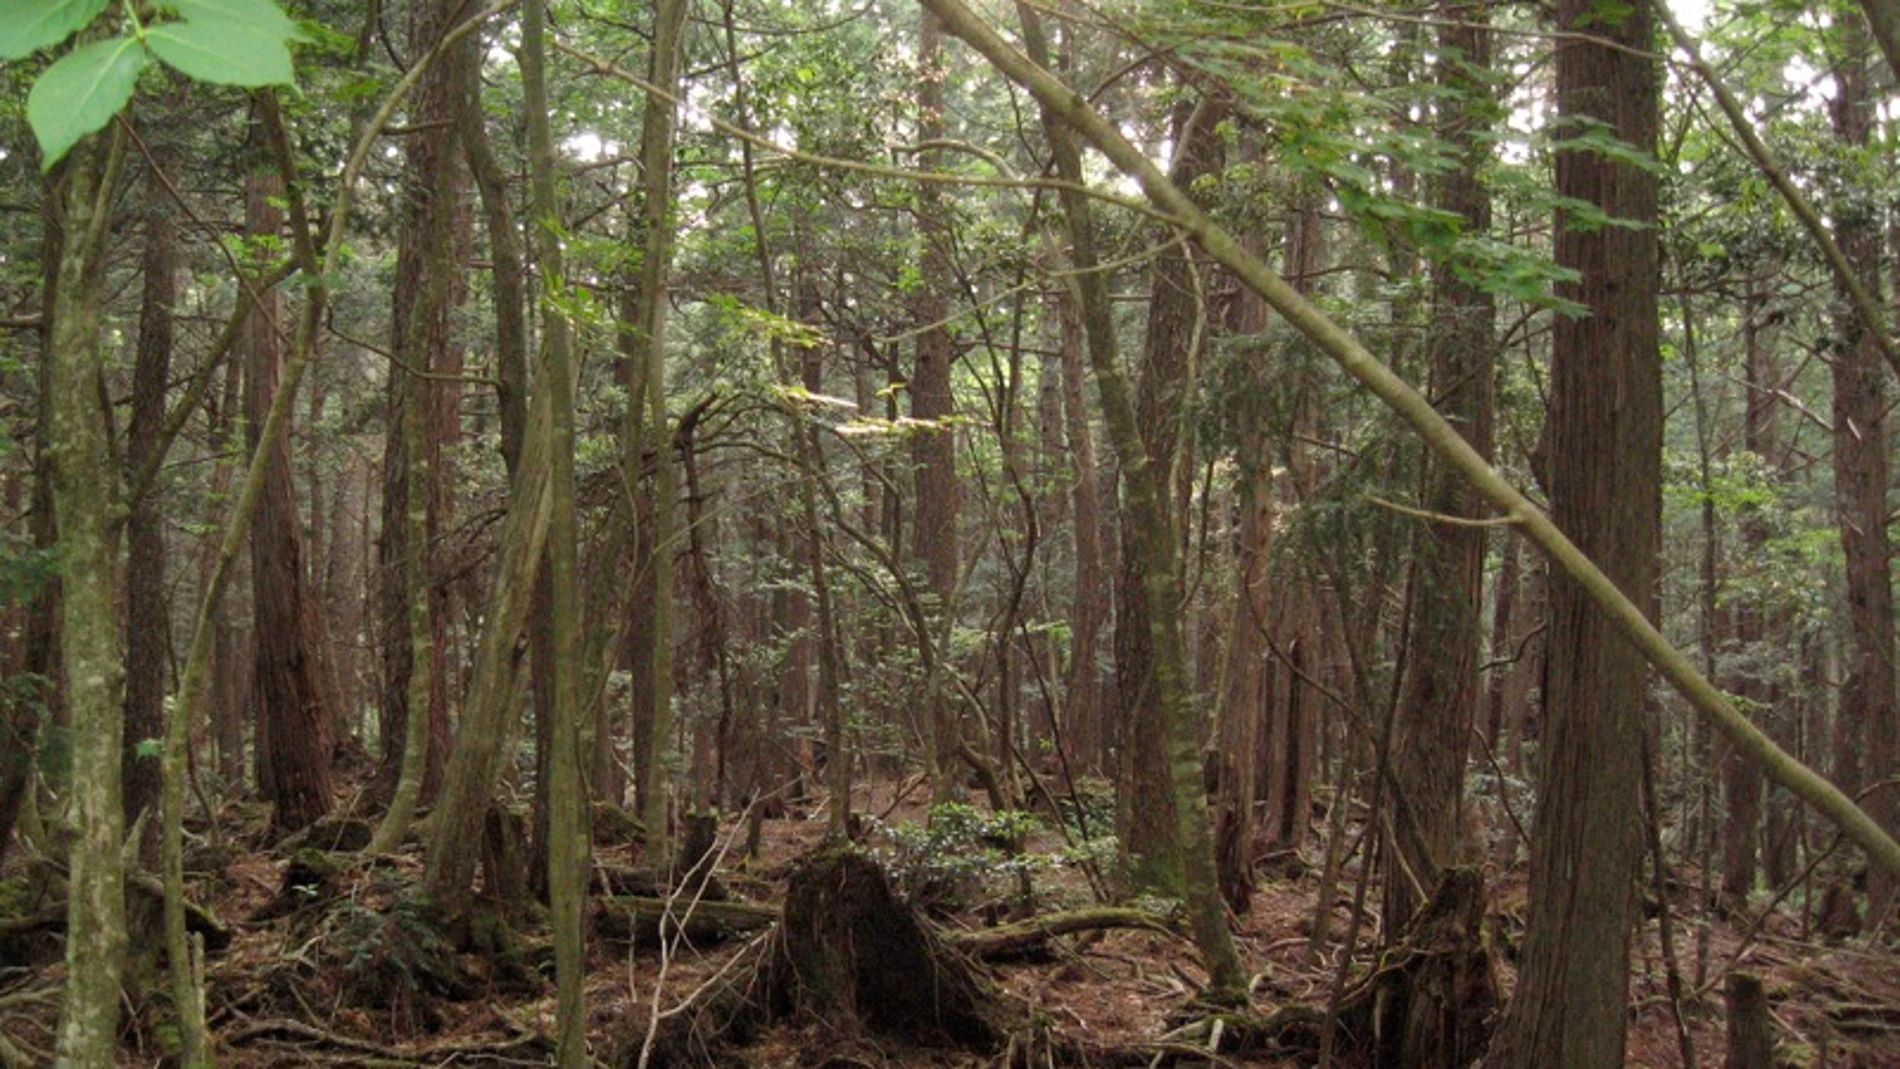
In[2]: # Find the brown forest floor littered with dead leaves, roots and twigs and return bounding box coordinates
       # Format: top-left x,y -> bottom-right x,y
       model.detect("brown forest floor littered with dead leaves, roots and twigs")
0,786 -> 1900,1069
